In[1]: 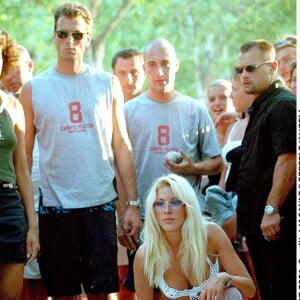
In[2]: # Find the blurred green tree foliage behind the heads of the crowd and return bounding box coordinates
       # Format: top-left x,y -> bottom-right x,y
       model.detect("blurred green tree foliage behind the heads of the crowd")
0,0 -> 296,98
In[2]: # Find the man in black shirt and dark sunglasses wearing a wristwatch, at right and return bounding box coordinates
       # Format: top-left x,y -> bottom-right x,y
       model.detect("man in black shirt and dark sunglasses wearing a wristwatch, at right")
236,40 -> 296,300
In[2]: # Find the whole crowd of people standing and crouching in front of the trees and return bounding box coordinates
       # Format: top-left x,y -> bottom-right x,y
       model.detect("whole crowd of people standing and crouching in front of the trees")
0,2 -> 297,300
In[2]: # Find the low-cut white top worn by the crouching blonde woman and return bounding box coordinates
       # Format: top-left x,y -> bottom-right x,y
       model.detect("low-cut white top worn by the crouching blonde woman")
158,257 -> 219,300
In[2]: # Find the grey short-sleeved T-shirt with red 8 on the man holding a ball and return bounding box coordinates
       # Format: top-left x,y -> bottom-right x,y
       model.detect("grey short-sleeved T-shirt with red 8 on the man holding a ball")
124,92 -> 221,218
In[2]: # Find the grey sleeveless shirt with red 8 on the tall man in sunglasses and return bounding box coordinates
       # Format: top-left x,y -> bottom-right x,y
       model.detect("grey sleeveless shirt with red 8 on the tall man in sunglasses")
30,66 -> 116,208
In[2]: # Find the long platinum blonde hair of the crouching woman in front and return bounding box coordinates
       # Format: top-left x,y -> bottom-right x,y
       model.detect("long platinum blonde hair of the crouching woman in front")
141,174 -> 207,286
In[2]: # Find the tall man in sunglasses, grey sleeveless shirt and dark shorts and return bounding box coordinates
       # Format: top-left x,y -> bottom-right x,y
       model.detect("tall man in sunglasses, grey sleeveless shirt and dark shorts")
20,3 -> 141,300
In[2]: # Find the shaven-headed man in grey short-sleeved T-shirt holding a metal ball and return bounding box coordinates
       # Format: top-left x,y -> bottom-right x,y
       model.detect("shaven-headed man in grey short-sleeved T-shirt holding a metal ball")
118,38 -> 223,296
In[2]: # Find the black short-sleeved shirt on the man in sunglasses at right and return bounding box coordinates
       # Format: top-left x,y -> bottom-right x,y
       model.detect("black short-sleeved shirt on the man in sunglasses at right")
237,81 -> 296,235
